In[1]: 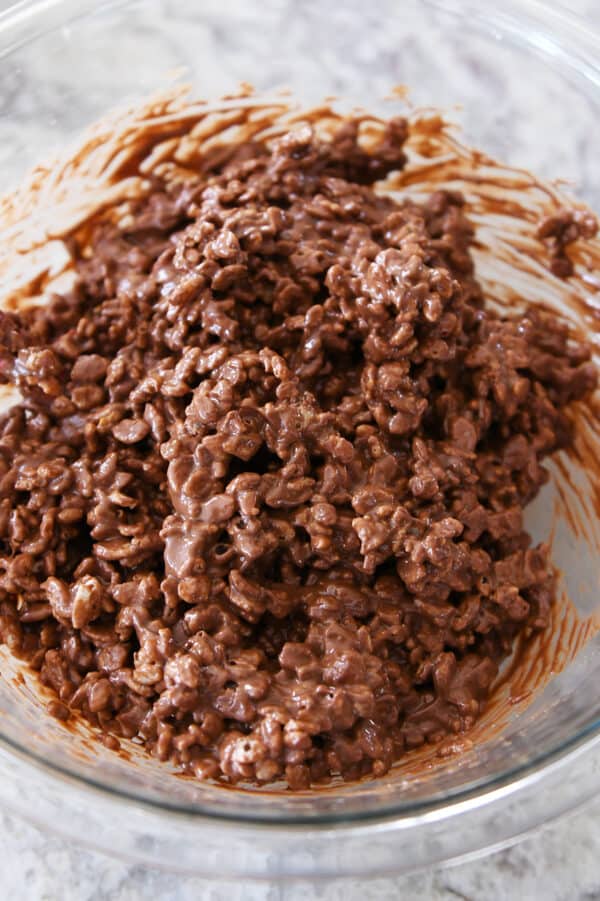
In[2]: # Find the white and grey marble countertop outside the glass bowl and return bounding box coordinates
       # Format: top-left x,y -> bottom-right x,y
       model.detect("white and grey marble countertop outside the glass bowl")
0,0 -> 600,901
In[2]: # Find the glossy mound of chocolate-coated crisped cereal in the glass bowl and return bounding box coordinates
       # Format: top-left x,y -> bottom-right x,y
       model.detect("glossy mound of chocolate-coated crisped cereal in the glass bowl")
0,120 -> 596,788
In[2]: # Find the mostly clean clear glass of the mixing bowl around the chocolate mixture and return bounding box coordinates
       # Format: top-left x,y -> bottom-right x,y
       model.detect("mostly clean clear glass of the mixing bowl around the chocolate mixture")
0,0 -> 600,879
